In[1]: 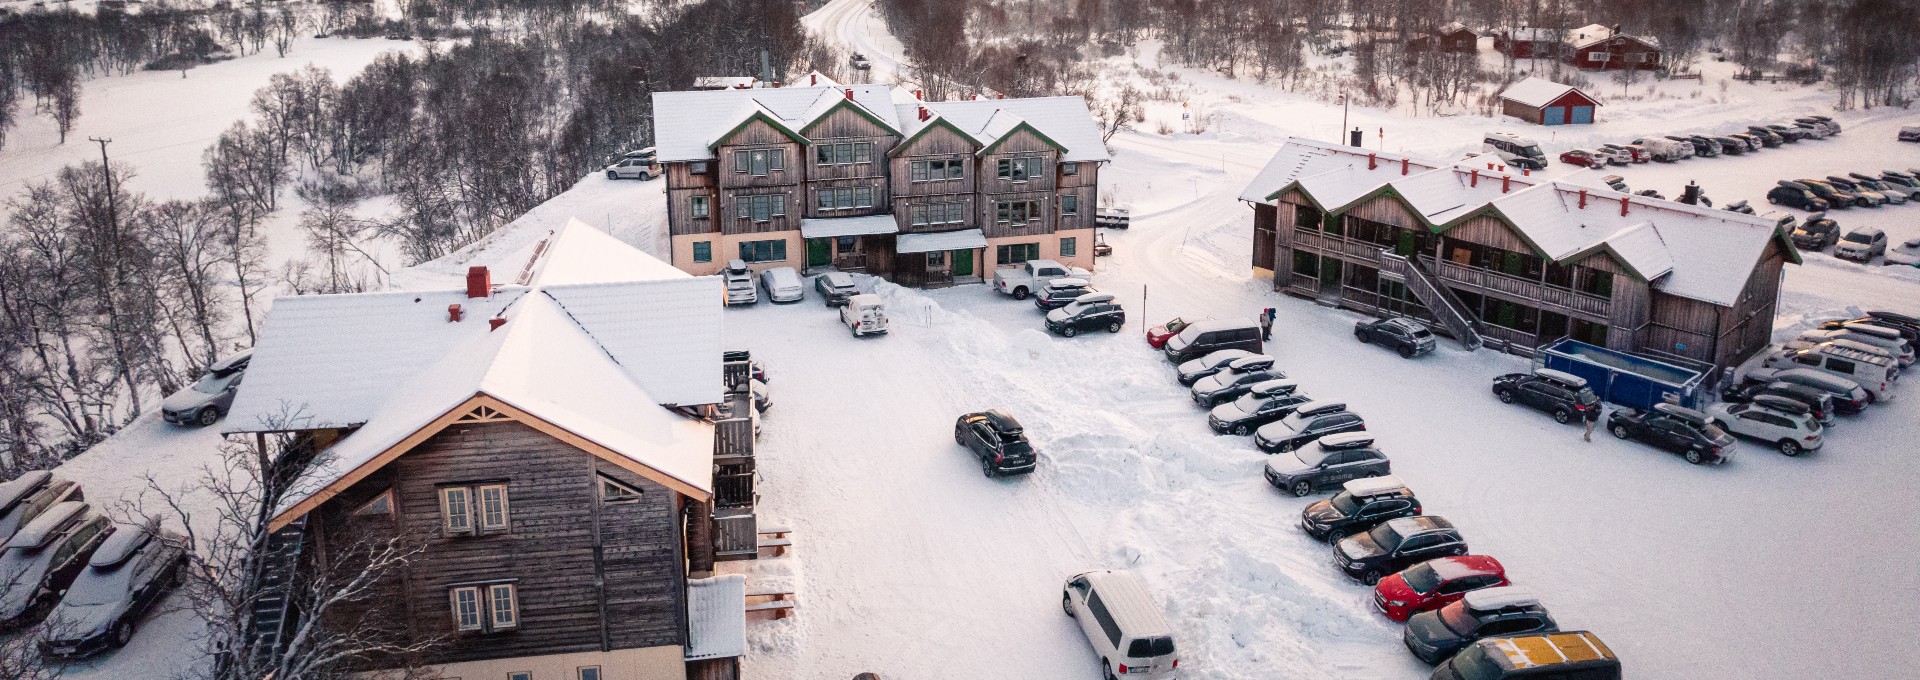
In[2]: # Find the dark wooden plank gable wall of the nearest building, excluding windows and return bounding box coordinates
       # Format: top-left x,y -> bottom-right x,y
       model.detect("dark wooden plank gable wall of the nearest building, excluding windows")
313,422 -> 685,663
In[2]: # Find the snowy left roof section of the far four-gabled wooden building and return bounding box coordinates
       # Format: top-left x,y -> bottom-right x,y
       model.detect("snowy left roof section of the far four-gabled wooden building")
653,85 -> 900,163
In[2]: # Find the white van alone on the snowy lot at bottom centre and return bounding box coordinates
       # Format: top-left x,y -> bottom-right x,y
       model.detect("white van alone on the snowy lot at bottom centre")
1060,571 -> 1181,680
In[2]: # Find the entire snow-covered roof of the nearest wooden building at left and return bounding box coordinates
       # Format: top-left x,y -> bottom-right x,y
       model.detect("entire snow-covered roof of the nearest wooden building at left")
227,221 -> 724,526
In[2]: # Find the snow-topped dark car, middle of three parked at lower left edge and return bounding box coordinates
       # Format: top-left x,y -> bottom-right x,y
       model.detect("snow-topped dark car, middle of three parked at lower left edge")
0,501 -> 113,632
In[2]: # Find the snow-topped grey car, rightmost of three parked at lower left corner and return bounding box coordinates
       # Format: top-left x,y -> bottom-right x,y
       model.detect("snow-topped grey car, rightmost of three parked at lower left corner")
40,526 -> 186,659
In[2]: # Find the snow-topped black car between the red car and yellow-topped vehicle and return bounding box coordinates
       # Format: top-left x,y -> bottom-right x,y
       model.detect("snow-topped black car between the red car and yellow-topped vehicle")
1400,586 -> 1559,663
